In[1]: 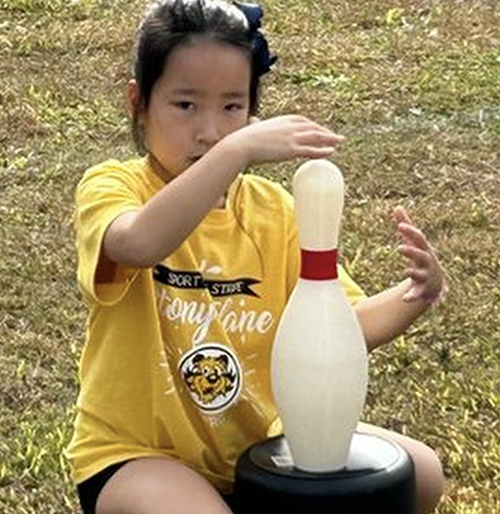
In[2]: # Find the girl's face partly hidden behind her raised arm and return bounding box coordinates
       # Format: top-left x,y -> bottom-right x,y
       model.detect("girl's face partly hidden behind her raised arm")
137,37 -> 251,177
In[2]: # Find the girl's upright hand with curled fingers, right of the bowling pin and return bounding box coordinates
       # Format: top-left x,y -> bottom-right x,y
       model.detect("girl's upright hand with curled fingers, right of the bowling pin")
394,206 -> 448,304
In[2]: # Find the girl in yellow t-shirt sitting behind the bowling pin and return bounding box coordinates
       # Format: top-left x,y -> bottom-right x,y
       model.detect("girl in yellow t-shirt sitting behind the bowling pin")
68,0 -> 444,514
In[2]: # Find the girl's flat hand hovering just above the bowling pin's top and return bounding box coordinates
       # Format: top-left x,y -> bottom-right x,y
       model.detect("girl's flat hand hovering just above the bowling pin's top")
226,115 -> 344,166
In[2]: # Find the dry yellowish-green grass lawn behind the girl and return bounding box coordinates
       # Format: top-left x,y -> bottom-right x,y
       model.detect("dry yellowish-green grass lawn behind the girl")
0,0 -> 500,514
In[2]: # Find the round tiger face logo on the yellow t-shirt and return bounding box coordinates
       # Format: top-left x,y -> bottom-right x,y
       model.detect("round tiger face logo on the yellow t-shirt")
179,343 -> 241,413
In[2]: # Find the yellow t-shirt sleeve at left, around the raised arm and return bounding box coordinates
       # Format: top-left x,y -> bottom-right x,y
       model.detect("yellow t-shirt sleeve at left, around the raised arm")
75,161 -> 142,305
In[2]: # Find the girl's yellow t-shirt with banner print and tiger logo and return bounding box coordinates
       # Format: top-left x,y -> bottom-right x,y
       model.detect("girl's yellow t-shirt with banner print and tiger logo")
67,155 -> 363,492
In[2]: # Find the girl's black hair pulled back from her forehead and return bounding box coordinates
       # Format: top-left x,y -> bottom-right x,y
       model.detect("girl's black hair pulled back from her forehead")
132,0 -> 274,152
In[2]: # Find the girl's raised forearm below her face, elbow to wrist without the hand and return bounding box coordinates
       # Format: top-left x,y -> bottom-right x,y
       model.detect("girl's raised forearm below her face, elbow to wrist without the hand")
105,136 -> 246,267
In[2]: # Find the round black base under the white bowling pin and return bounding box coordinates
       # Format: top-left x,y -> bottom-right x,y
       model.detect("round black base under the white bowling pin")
233,433 -> 416,514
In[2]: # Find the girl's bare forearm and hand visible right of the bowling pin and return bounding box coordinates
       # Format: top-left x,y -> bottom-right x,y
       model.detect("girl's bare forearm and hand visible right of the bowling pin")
355,207 -> 447,350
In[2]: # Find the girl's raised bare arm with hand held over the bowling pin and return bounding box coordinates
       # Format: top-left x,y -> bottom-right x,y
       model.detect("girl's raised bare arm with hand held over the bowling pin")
104,115 -> 342,267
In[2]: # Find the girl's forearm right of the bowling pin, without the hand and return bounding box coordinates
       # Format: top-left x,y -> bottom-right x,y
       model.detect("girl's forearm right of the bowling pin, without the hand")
355,279 -> 429,351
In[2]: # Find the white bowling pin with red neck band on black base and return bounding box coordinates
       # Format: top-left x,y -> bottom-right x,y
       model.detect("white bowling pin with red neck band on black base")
271,159 -> 368,472
